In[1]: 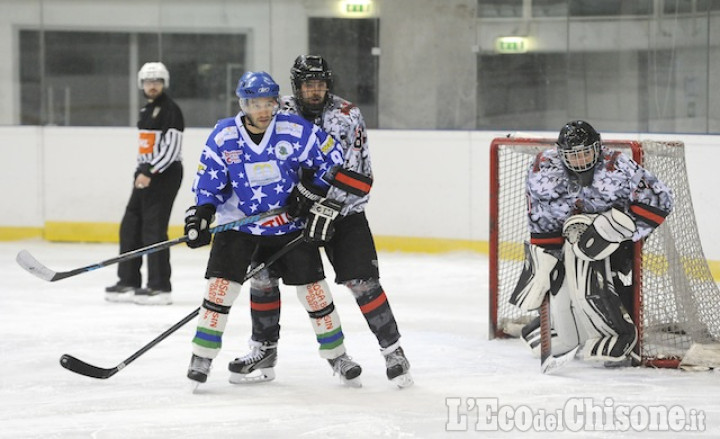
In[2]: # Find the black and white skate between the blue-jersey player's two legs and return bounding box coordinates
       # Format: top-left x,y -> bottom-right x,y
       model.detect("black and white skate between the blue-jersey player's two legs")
228,340 -> 277,384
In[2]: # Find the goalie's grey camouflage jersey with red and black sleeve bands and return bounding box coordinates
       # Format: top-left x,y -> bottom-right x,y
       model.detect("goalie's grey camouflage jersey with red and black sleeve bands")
526,148 -> 673,247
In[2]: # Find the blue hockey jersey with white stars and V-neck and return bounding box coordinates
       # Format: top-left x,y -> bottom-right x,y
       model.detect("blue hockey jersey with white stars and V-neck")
193,113 -> 343,235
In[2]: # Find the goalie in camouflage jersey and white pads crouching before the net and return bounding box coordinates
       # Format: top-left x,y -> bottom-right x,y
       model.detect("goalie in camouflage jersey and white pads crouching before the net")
510,120 -> 673,367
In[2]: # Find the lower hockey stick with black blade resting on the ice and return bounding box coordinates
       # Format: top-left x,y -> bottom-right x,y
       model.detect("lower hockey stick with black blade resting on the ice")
60,235 -> 303,379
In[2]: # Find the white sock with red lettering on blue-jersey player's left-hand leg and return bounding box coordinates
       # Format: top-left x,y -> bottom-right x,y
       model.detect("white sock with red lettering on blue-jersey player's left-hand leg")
192,277 -> 240,359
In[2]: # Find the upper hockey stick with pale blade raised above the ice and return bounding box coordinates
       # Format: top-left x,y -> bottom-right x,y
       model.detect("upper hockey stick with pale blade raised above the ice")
15,208 -> 285,282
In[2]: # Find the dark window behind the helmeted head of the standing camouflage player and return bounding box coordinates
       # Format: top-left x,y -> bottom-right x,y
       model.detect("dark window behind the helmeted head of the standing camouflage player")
306,18 -> 380,128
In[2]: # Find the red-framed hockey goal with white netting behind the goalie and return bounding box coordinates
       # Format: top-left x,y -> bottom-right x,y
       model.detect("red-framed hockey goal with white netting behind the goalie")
489,138 -> 720,367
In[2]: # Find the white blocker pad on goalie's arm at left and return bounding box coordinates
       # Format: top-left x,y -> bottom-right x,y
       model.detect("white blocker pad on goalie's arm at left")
510,242 -> 563,312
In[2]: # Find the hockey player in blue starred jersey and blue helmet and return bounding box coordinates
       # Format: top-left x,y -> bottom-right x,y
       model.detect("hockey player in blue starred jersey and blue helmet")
185,72 -> 360,383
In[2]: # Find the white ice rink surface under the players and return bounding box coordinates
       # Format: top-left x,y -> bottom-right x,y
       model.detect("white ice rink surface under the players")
0,240 -> 720,439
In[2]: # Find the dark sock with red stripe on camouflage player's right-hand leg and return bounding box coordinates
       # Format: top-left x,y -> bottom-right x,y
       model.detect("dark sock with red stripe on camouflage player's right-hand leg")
345,279 -> 400,348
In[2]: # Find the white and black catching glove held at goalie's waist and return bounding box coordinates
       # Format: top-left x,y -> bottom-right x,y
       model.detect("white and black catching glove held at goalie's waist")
563,208 -> 636,261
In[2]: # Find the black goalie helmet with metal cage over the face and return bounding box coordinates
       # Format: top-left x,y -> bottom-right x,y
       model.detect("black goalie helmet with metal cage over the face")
557,120 -> 602,173
